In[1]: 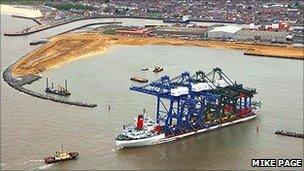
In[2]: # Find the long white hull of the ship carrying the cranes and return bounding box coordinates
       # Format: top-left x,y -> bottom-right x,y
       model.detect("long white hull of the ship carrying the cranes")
116,114 -> 257,148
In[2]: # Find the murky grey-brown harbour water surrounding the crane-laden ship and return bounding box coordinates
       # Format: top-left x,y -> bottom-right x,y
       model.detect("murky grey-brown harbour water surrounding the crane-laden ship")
1,15 -> 303,170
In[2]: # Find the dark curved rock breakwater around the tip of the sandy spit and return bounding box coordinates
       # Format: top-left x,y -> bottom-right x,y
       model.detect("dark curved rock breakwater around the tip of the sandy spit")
3,64 -> 97,108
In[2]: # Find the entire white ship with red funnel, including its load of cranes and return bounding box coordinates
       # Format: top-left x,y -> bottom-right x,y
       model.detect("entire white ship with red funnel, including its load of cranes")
115,68 -> 261,148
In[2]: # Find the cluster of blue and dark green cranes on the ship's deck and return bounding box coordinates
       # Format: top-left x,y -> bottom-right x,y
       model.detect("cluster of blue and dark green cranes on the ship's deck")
130,68 -> 256,136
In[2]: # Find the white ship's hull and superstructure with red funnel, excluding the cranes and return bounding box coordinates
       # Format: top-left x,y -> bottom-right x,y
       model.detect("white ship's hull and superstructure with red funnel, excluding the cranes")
115,112 -> 257,148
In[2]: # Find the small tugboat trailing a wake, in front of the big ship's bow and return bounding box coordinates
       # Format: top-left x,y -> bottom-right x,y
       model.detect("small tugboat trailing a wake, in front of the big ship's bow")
44,150 -> 79,164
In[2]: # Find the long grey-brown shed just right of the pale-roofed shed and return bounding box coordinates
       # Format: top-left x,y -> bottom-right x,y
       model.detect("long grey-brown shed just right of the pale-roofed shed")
235,29 -> 290,43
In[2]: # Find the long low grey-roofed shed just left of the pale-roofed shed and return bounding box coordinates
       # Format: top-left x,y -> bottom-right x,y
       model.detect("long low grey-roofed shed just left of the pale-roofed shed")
154,26 -> 208,37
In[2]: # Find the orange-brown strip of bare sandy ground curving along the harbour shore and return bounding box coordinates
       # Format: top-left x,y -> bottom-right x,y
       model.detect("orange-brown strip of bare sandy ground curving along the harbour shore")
12,33 -> 304,76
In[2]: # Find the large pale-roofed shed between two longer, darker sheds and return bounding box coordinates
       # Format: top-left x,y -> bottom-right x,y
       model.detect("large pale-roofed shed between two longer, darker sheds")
208,26 -> 242,39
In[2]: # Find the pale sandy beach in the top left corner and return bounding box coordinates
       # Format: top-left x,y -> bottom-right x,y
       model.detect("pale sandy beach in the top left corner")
1,4 -> 42,18
